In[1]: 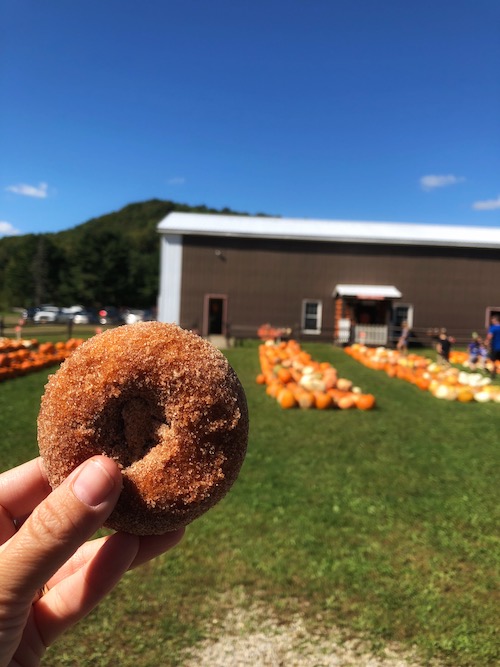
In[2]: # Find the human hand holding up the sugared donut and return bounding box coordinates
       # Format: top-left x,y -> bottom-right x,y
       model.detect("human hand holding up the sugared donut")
0,456 -> 184,667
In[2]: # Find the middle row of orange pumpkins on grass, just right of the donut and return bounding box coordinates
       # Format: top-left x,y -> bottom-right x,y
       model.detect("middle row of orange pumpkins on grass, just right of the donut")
256,340 -> 375,410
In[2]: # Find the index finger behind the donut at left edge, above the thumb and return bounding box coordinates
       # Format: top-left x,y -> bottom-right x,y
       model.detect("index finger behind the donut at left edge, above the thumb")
0,457 -> 52,519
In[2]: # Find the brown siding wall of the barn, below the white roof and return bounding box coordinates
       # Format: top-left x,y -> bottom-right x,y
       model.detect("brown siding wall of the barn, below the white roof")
181,236 -> 500,338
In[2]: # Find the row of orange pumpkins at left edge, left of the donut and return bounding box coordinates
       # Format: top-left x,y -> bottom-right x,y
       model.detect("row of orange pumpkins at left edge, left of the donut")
0,338 -> 83,382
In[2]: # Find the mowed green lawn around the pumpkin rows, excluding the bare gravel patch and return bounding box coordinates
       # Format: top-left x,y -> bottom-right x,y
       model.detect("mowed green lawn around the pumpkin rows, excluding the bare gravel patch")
0,343 -> 500,667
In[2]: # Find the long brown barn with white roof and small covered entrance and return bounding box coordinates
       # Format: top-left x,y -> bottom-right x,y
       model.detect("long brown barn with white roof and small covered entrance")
158,212 -> 500,345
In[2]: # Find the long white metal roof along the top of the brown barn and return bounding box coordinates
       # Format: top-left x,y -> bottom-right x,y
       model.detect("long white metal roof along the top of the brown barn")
158,212 -> 500,248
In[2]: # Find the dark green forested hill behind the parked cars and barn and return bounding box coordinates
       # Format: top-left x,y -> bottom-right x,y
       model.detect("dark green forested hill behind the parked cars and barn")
0,199 -> 250,310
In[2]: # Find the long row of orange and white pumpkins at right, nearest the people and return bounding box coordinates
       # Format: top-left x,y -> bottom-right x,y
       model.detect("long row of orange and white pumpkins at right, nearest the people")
345,343 -> 500,403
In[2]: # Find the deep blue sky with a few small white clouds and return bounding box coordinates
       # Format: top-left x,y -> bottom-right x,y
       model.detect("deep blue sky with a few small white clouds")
0,0 -> 500,235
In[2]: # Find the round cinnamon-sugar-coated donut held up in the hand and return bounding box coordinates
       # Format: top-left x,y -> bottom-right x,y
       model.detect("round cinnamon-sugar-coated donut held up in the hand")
37,322 -> 248,535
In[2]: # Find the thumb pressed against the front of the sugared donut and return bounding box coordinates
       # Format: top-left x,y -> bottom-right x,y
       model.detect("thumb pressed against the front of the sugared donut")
0,456 -> 122,606
